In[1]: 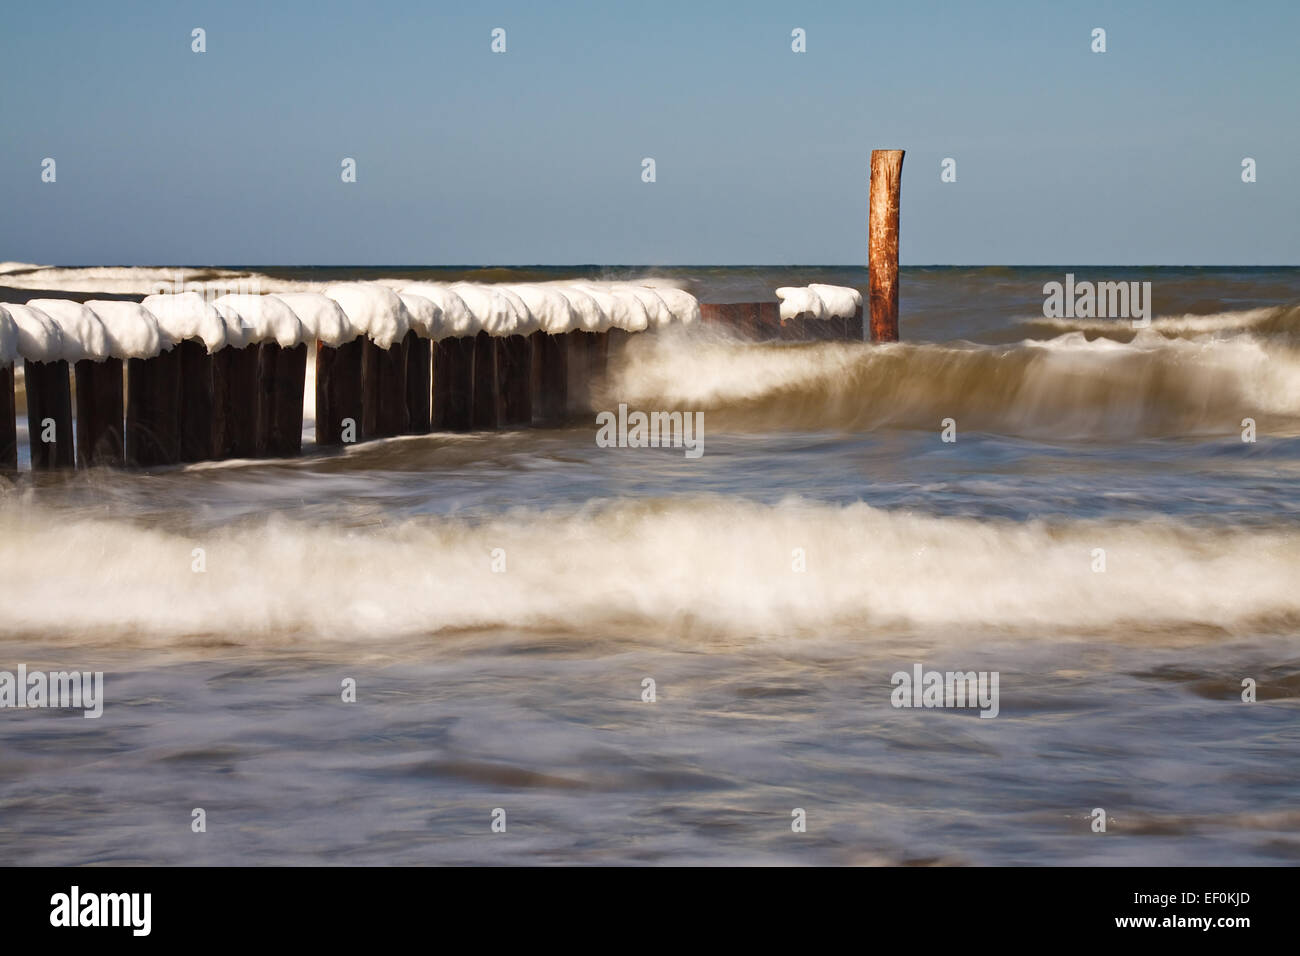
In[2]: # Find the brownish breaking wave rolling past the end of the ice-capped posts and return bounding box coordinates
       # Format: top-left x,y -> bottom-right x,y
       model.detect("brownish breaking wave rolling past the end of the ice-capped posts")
599,323 -> 1300,440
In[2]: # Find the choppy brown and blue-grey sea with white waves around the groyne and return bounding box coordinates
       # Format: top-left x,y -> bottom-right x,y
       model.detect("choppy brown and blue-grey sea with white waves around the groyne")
0,267 -> 1300,864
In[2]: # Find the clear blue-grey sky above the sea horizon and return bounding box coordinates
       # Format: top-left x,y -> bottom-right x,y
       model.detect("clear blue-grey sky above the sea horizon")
0,0 -> 1300,265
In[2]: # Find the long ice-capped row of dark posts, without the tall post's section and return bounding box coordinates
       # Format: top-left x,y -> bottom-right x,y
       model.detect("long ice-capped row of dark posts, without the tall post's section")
0,281 -> 699,467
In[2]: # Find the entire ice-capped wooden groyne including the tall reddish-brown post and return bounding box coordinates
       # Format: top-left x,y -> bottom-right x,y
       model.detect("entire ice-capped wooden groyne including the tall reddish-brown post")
0,150 -> 904,472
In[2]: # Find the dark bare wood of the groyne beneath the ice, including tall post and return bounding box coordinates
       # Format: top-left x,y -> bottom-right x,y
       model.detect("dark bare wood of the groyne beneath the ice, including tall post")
0,150 -> 904,472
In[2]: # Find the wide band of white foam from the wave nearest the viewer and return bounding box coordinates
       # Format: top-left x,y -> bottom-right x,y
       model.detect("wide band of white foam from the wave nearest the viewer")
0,498 -> 1300,644
